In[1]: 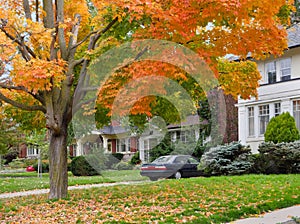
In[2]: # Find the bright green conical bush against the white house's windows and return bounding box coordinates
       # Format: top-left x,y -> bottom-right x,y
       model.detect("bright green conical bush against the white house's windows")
265,112 -> 300,144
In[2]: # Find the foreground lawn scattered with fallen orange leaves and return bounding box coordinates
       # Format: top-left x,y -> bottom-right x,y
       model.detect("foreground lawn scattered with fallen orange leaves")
0,175 -> 300,223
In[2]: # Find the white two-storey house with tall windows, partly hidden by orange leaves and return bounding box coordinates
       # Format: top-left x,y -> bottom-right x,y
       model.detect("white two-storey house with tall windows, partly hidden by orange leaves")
237,24 -> 300,153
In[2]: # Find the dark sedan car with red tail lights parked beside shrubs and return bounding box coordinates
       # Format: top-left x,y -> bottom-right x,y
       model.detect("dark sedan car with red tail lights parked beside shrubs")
140,155 -> 200,181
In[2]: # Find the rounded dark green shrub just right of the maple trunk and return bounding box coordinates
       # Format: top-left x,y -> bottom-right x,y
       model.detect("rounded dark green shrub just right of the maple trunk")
71,154 -> 106,176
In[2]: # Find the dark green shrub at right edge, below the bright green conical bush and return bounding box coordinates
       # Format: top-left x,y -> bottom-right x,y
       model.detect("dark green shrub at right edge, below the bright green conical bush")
253,142 -> 300,174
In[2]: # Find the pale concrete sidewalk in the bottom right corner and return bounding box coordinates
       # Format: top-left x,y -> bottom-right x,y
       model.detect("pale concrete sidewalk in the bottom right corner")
231,205 -> 300,224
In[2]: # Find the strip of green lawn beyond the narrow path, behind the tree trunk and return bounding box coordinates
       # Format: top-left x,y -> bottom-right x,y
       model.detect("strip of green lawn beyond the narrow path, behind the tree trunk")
0,170 -> 147,193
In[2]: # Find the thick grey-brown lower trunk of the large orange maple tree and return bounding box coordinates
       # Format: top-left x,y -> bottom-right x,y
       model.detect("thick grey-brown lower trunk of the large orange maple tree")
49,122 -> 68,199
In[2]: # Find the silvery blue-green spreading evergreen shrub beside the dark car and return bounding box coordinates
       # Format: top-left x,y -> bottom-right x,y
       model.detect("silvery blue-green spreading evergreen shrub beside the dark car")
198,142 -> 253,175
